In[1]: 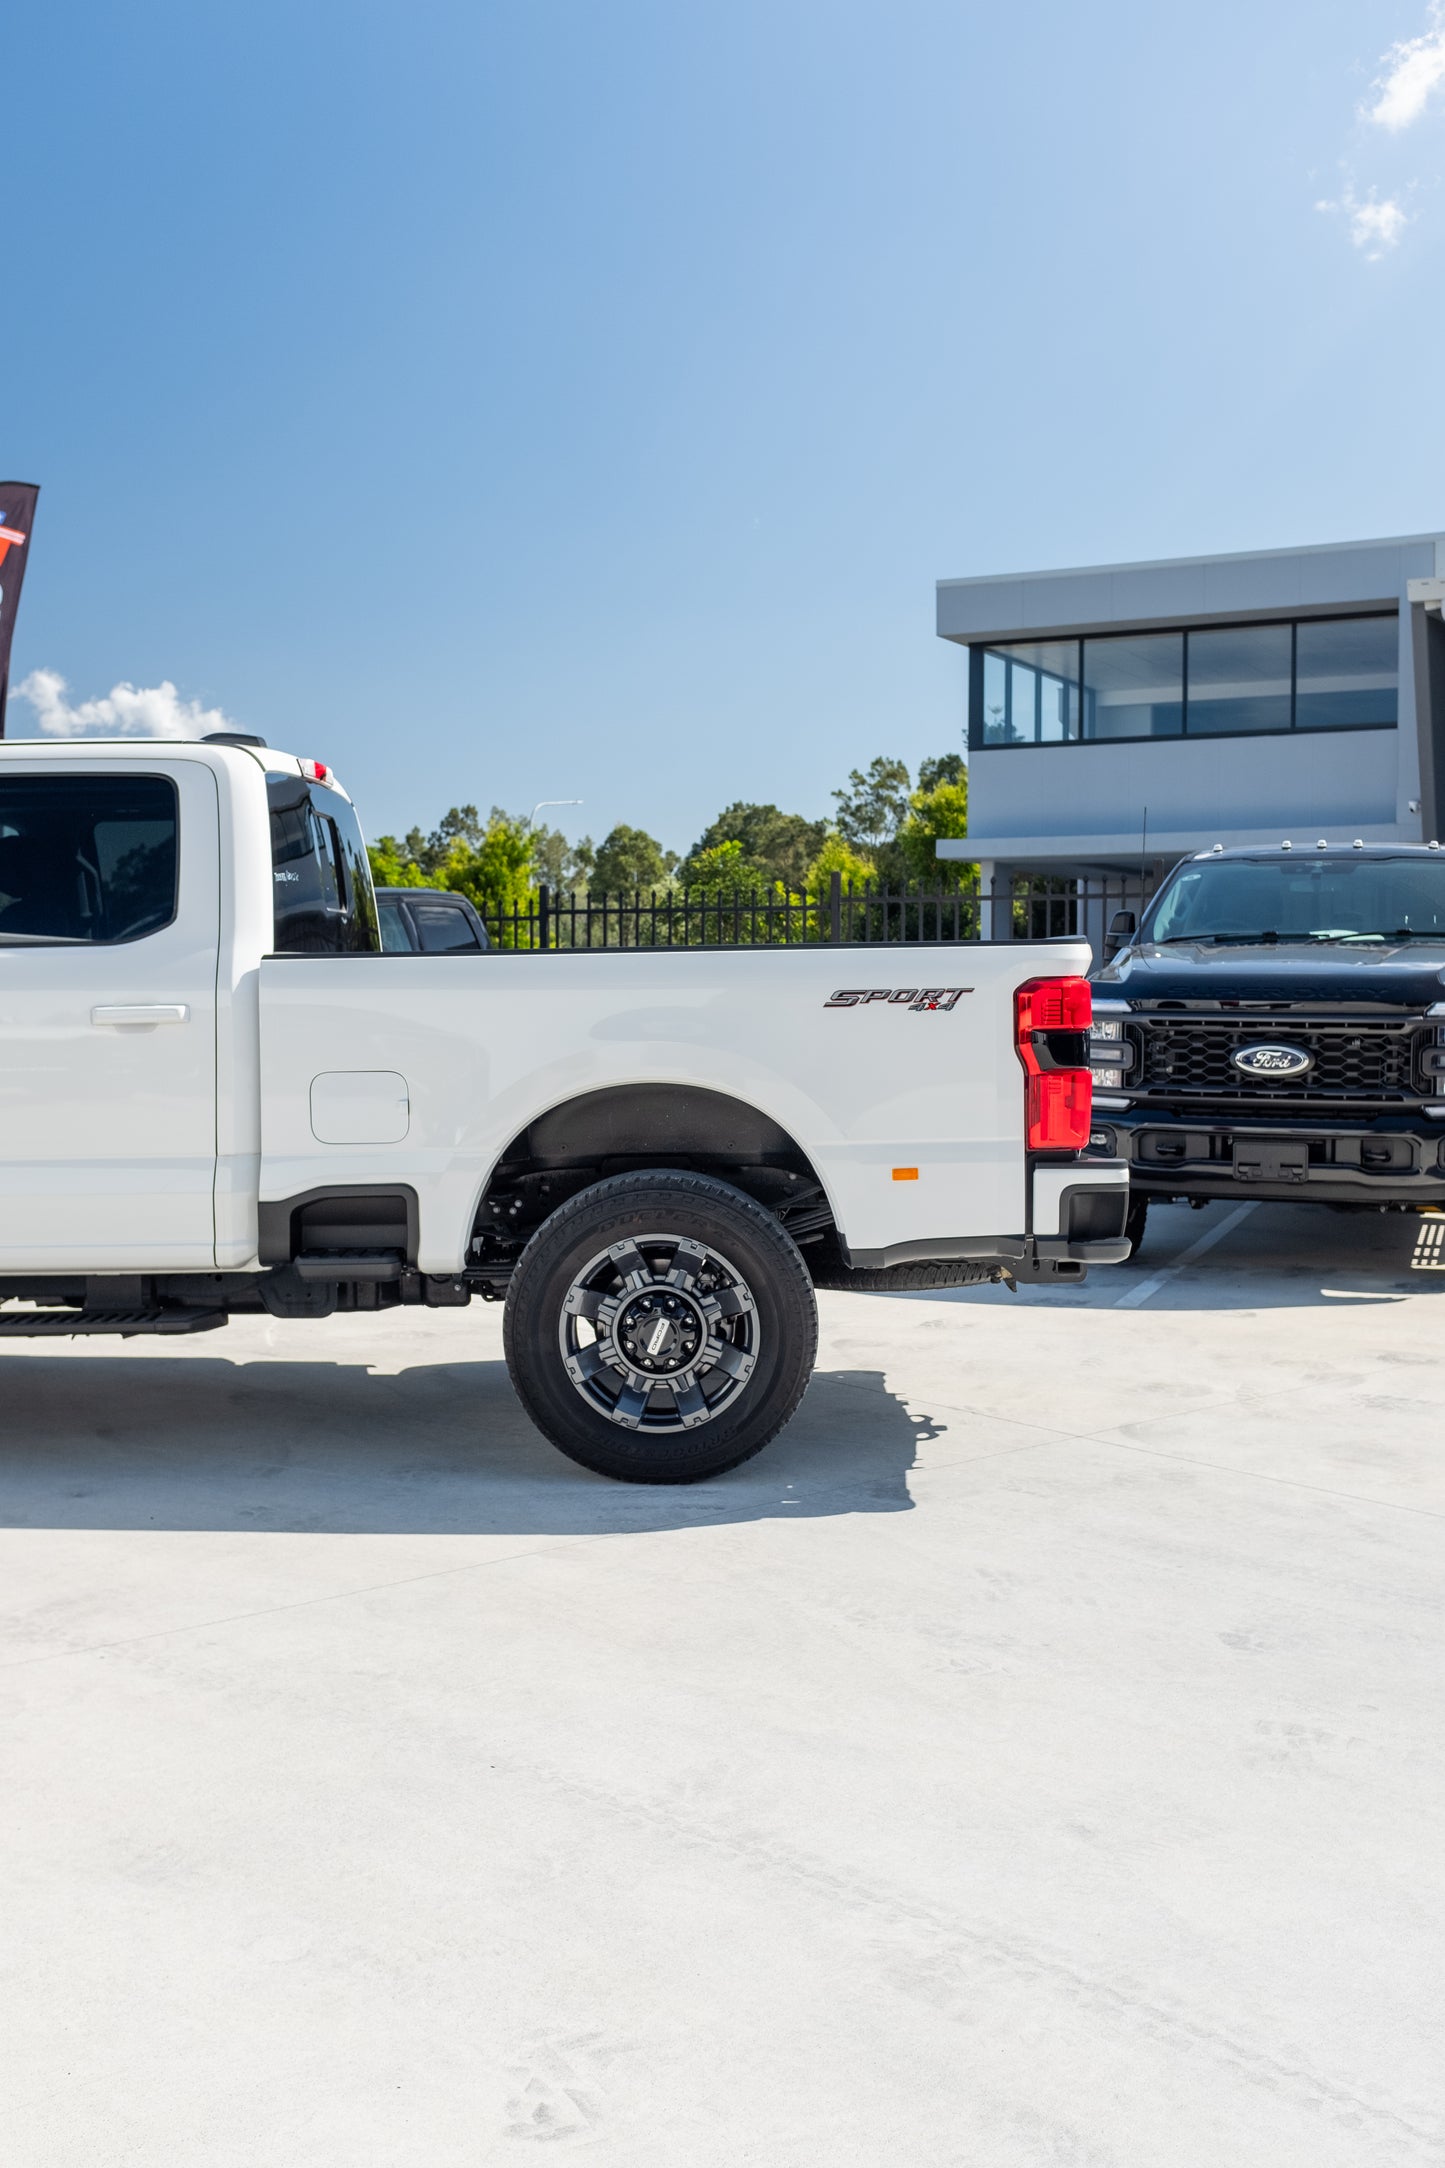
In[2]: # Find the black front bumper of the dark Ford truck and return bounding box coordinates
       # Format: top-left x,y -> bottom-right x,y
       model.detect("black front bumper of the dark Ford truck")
1090,1106 -> 1445,1205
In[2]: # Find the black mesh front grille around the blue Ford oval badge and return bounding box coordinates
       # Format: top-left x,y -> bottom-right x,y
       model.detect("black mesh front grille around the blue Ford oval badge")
1127,1015 -> 1430,1108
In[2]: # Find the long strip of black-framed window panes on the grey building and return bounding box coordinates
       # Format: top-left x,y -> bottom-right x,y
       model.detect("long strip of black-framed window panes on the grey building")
968,616 -> 1400,746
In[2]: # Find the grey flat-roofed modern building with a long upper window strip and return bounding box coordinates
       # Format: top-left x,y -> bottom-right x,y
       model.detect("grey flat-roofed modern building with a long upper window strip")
938,533 -> 1445,927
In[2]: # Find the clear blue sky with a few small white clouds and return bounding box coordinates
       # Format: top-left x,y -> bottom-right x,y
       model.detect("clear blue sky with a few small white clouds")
0,0 -> 1445,848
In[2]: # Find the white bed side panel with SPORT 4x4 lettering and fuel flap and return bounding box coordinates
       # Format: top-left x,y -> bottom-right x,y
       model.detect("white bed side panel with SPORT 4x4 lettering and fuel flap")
260,943 -> 1088,1273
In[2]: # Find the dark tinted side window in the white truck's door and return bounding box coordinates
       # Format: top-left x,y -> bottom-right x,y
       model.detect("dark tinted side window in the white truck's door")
0,774 -> 178,943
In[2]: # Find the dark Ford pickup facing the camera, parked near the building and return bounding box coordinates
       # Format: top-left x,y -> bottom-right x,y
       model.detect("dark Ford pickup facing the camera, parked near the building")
1092,843 -> 1445,1247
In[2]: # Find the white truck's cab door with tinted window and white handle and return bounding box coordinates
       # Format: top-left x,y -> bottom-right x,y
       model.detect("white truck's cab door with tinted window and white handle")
0,748 -> 221,1273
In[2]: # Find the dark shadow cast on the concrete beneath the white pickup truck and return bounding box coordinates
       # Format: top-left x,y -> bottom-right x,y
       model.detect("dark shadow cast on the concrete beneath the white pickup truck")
0,1353 -> 942,1535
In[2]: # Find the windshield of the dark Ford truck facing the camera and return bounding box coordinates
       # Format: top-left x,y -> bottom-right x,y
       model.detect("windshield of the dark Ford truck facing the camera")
1144,852 -> 1445,941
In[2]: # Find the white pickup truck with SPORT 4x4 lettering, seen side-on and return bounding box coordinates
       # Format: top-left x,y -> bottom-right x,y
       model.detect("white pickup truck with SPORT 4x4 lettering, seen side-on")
0,735 -> 1129,1483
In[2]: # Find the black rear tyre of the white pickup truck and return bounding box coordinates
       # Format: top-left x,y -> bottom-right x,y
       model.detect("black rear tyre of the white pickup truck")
503,1169 -> 817,1483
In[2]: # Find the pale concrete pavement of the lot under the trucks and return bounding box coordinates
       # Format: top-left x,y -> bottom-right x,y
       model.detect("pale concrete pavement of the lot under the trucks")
0,1208 -> 1445,2168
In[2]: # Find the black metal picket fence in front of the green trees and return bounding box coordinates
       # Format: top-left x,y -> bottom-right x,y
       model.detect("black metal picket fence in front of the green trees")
479,874 -> 1155,954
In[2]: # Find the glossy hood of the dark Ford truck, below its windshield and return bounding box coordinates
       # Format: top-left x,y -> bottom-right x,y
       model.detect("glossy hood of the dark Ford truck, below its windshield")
1094,941 -> 1445,1010
